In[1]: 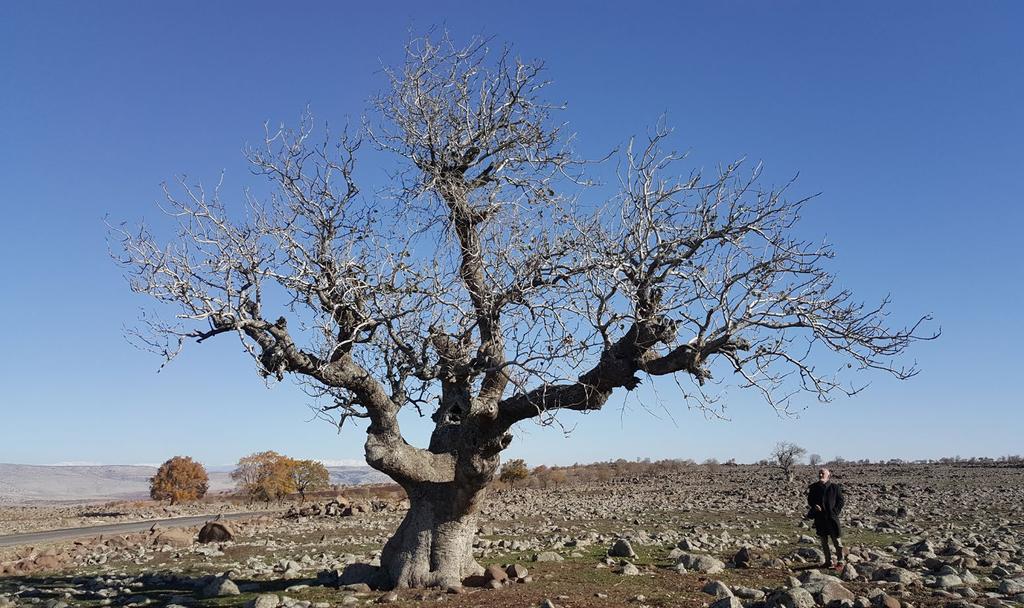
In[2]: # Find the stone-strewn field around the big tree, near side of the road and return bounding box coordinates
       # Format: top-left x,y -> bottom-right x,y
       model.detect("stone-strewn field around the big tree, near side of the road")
0,458 -> 1024,608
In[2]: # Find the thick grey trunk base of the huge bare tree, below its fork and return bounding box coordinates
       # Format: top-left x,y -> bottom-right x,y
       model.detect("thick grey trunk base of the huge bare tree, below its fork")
380,482 -> 486,589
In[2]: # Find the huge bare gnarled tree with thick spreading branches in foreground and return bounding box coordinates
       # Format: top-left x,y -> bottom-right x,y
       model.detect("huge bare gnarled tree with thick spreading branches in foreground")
117,37 -> 937,588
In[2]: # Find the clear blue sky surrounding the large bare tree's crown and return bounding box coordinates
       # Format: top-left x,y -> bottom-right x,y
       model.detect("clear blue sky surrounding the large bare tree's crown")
0,2 -> 1024,465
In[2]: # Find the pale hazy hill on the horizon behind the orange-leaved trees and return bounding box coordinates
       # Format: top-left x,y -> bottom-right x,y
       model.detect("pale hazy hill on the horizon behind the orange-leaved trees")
0,464 -> 388,505
